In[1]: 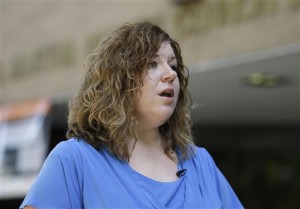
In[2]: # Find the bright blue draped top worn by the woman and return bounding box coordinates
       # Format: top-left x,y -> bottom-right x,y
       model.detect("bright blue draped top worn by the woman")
20,138 -> 243,209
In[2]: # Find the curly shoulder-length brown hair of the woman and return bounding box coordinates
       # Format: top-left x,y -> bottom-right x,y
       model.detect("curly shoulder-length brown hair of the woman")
67,22 -> 193,161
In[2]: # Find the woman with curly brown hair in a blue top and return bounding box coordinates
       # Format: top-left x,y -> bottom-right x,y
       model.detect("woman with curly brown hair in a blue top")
21,22 -> 242,209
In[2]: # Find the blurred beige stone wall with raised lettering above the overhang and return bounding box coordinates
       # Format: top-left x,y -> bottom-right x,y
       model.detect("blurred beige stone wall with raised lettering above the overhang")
0,0 -> 300,104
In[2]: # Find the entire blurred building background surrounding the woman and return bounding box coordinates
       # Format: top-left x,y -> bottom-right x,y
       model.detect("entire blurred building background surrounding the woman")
0,0 -> 300,209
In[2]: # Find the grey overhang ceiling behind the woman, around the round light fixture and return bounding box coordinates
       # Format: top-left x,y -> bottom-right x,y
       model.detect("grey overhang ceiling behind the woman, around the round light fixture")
189,43 -> 300,125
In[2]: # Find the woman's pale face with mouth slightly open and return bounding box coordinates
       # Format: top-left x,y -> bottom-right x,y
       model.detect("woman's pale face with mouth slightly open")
135,42 -> 180,129
